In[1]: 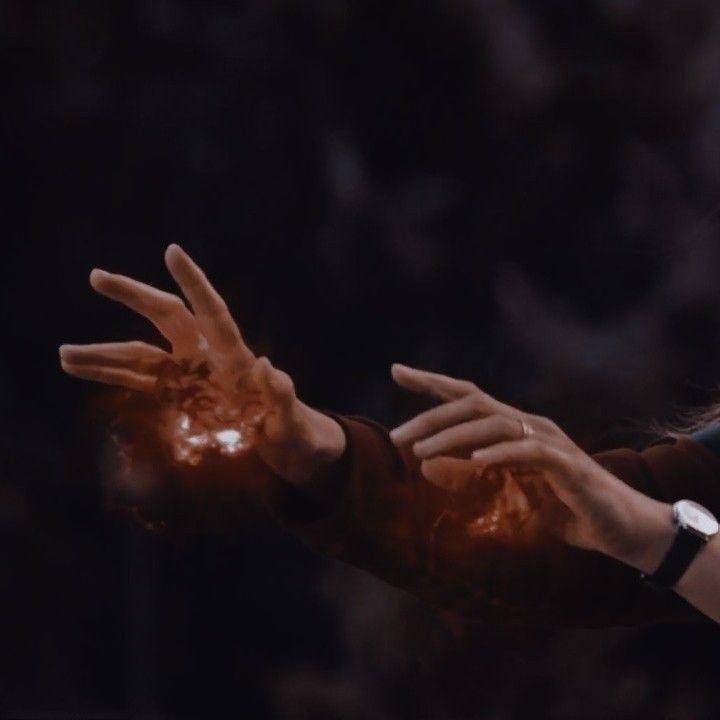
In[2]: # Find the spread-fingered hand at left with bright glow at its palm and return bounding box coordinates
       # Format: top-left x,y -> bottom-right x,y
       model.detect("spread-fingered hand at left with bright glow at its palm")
60,245 -> 345,483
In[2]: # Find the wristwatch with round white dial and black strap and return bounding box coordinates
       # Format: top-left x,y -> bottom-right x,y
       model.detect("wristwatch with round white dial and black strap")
641,500 -> 720,589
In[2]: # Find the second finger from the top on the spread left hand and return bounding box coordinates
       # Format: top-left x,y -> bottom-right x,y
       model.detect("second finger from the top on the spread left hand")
90,268 -> 201,354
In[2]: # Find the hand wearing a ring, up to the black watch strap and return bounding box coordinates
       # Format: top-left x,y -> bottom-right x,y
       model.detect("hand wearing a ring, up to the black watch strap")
390,365 -> 673,572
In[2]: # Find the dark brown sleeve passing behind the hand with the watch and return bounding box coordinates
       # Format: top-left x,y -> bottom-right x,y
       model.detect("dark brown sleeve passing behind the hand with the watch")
269,411 -> 720,626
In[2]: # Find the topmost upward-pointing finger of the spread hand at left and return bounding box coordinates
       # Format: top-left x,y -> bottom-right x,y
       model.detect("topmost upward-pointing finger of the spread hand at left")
165,245 -> 255,367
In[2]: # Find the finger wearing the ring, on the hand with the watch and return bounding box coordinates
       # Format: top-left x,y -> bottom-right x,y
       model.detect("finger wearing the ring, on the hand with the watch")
413,415 -> 524,458
